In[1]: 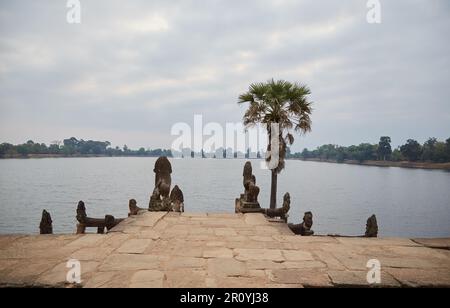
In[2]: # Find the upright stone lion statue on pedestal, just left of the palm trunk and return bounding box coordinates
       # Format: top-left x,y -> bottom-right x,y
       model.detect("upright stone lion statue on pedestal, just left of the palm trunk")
235,161 -> 261,213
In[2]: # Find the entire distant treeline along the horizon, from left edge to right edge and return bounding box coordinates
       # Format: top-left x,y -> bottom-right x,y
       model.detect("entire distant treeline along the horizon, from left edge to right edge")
0,136 -> 450,163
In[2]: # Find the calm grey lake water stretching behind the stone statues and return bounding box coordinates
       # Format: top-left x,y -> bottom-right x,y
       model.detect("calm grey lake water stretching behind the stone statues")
0,158 -> 450,237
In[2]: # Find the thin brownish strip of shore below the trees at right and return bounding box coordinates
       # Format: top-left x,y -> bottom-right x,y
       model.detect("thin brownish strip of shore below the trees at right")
294,158 -> 450,171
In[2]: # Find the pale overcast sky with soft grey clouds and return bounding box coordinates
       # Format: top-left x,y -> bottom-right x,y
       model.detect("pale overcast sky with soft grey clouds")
0,0 -> 450,151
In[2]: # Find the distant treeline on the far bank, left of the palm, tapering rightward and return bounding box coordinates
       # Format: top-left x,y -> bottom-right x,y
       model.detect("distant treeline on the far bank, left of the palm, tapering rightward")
0,137 -> 172,157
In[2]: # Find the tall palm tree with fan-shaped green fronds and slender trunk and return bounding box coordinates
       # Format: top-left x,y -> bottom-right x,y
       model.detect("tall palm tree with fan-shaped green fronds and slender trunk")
238,79 -> 312,209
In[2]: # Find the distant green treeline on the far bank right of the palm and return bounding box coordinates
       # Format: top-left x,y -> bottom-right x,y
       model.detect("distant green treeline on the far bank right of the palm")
287,137 -> 450,163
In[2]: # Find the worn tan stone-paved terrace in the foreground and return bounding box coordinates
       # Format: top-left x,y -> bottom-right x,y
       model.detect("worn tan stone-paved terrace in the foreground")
0,212 -> 450,288
